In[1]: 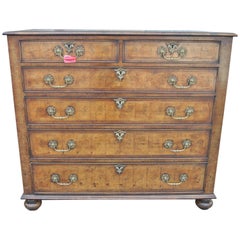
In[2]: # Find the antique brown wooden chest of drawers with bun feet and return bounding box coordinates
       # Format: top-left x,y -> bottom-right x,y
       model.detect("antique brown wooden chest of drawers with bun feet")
5,30 -> 235,210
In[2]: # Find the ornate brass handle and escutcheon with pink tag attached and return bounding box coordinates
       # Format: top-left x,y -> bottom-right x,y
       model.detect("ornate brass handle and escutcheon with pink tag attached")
53,42 -> 85,63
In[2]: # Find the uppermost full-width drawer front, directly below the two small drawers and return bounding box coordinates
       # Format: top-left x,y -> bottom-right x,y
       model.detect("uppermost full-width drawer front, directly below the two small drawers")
23,67 -> 217,92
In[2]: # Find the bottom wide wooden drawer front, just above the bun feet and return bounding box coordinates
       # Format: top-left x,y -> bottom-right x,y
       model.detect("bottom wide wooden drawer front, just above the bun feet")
32,164 -> 205,193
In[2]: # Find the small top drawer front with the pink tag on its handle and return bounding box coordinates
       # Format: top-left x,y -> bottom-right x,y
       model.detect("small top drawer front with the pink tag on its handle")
20,40 -> 118,62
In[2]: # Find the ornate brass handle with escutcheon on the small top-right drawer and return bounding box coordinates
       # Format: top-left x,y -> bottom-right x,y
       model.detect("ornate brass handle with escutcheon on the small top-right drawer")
157,42 -> 187,60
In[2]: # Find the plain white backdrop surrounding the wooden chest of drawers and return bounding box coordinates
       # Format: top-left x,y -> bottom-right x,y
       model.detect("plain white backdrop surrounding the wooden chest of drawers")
0,0 -> 240,240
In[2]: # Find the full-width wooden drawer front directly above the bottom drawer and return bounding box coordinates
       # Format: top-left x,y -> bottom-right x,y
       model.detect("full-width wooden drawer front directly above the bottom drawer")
30,129 -> 209,158
